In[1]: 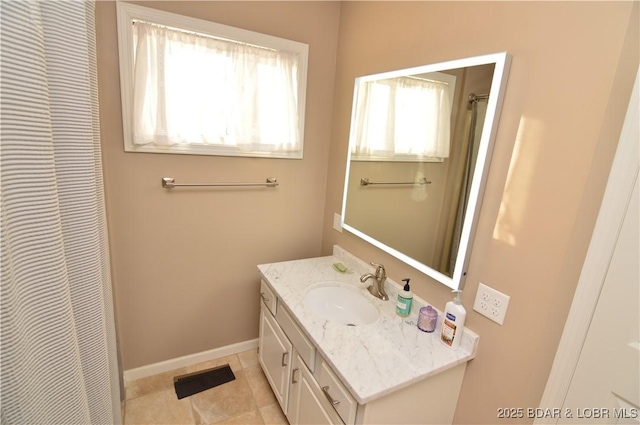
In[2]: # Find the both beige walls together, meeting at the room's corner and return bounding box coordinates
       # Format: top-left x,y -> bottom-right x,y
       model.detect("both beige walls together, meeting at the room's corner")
97,1 -> 639,424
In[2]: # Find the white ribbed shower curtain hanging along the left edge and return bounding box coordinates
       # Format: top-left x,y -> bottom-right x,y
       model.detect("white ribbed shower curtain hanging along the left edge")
0,1 -> 120,425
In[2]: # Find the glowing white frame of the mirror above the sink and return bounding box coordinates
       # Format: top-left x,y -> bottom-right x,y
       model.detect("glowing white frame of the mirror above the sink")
340,52 -> 511,289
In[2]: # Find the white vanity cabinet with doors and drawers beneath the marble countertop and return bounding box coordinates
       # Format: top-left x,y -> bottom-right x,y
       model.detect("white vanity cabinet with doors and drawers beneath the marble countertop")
258,270 -> 466,425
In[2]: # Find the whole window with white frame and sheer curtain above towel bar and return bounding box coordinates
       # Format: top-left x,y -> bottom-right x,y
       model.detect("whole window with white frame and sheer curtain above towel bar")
117,2 -> 308,158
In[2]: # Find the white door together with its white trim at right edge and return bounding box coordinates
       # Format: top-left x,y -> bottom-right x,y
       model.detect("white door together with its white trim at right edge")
530,68 -> 640,424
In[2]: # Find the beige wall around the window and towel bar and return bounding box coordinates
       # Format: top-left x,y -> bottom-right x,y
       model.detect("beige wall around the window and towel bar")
97,1 -> 340,370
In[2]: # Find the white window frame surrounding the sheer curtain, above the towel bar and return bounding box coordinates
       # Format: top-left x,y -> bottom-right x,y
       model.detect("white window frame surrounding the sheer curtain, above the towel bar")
116,1 -> 309,159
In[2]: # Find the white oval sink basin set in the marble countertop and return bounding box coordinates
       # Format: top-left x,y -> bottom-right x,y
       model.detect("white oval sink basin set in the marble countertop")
304,285 -> 379,326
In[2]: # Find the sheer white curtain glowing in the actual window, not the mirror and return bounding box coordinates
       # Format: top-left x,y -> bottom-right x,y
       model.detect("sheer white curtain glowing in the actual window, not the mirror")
133,21 -> 300,152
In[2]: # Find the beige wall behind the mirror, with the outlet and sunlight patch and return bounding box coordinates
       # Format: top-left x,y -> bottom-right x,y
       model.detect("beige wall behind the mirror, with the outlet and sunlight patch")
322,2 -> 639,424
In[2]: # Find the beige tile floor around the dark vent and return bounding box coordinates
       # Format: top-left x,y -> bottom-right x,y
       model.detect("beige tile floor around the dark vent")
123,350 -> 288,425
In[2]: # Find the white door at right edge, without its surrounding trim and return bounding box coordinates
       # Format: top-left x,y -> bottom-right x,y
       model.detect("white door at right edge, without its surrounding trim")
558,174 -> 640,424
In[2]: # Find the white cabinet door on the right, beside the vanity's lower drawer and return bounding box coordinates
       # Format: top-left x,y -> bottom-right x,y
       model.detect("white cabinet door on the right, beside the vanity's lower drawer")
286,353 -> 342,425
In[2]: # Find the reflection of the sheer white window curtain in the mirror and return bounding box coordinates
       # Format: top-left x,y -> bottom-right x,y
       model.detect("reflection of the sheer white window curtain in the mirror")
351,77 -> 451,159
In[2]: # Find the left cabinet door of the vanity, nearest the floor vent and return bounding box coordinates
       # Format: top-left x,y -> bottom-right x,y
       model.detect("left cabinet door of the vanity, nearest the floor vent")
258,303 -> 292,412
